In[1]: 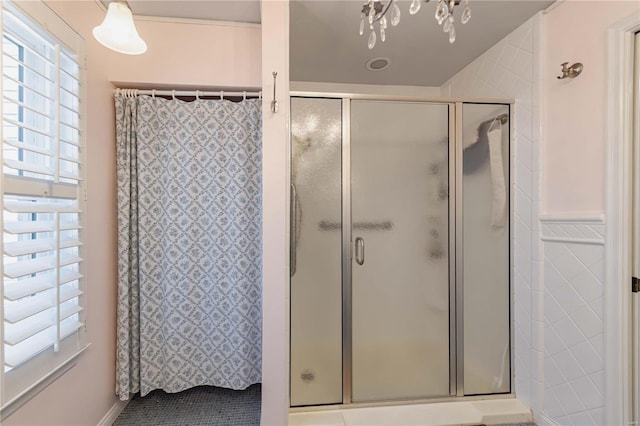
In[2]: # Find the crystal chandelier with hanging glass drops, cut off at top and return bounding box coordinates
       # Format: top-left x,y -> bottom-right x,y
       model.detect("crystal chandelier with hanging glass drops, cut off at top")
360,0 -> 471,49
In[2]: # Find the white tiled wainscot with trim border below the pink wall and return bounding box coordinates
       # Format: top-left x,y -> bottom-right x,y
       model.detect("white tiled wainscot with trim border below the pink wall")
539,219 -> 605,426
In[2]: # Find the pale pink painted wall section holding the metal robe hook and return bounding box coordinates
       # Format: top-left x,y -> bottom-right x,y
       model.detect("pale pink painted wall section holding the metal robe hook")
541,0 -> 640,213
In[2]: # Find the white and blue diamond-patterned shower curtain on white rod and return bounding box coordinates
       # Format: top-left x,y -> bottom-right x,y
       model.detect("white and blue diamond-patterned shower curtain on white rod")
115,94 -> 262,400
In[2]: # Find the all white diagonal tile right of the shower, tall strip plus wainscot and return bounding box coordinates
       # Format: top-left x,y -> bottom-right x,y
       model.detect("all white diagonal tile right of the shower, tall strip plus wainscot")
442,14 -> 605,426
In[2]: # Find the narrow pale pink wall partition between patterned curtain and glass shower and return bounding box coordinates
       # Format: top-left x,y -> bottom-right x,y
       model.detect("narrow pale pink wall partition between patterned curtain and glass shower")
260,0 -> 289,426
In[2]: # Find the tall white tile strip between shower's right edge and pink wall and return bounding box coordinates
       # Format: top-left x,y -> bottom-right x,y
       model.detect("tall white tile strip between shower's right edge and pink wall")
442,16 -> 540,407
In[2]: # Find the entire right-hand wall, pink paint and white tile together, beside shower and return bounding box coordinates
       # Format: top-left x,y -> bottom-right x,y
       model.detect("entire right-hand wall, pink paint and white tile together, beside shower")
443,0 -> 640,425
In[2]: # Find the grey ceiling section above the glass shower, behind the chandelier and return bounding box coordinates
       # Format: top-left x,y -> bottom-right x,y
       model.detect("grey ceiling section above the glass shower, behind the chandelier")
290,0 -> 553,87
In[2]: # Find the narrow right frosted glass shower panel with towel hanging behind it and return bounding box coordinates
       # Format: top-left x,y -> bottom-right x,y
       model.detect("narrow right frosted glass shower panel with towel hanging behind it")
458,103 -> 511,395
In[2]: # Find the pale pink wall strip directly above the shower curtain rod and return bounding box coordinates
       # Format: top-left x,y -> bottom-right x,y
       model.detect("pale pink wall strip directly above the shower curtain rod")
107,17 -> 262,88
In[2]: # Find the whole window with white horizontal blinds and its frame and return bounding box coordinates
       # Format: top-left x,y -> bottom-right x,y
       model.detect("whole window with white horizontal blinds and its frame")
0,0 -> 86,414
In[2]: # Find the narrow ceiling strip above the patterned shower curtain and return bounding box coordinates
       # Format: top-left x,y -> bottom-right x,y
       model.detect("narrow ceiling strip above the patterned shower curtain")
100,0 -> 260,23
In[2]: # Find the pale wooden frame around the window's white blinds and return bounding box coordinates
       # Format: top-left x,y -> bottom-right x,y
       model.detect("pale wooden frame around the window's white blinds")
0,0 -> 89,422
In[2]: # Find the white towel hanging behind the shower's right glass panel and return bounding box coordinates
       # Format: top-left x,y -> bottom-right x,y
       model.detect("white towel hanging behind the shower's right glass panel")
487,126 -> 507,228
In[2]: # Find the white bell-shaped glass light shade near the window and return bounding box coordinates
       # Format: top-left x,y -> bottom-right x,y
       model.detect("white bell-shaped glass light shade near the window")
93,1 -> 147,55
